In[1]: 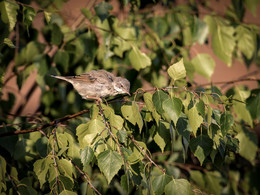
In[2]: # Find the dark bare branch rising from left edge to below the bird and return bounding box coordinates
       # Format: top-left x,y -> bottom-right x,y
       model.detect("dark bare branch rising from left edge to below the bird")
0,110 -> 89,137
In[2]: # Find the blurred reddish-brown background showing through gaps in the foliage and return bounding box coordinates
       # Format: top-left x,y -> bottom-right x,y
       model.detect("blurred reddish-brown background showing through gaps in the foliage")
3,0 -> 260,115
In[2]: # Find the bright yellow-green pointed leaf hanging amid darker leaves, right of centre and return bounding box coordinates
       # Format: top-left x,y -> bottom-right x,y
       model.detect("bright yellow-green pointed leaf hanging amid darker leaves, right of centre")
186,106 -> 203,136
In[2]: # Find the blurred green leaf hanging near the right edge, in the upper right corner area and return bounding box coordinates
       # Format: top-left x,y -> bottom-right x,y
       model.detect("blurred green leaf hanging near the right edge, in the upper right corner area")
236,25 -> 256,59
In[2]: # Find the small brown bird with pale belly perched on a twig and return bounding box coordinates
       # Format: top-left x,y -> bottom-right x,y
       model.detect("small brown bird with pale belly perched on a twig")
50,70 -> 130,102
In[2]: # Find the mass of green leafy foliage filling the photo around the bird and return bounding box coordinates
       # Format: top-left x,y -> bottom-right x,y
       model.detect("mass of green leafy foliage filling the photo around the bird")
0,0 -> 260,194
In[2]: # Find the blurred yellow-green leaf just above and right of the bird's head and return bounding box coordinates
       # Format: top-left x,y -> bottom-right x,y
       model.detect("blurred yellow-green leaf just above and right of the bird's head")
129,45 -> 152,71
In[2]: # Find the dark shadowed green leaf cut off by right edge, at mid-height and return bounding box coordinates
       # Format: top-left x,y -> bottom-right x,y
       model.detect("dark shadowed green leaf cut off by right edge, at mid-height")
246,89 -> 260,121
